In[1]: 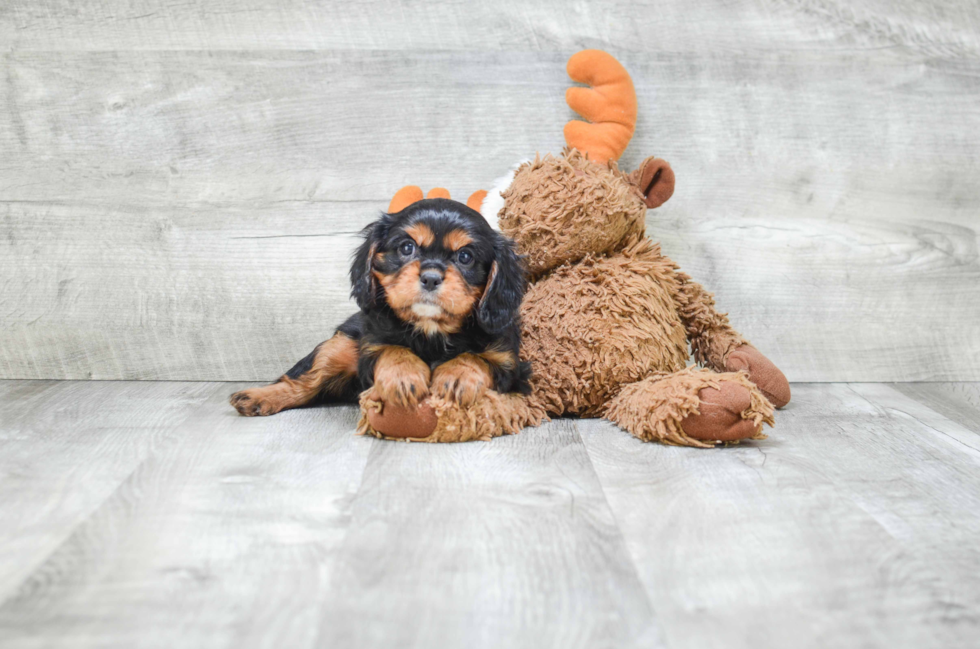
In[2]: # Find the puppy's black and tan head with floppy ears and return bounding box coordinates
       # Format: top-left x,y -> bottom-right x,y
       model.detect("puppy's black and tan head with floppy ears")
350,198 -> 525,336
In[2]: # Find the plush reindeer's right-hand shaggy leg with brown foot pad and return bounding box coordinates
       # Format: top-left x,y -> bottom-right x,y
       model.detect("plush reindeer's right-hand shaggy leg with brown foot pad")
605,367 -> 773,448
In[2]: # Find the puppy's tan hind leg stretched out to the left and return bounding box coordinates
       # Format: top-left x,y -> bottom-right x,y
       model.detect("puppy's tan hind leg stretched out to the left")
230,333 -> 358,417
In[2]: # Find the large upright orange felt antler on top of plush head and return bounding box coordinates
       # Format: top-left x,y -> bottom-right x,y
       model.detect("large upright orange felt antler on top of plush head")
565,50 -> 636,163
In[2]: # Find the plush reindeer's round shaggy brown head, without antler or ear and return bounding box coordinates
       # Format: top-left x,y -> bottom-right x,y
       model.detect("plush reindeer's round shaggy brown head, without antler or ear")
498,149 -> 646,275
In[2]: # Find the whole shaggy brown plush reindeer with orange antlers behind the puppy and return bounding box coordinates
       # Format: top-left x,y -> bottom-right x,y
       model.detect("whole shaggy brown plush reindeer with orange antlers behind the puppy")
361,50 -> 790,447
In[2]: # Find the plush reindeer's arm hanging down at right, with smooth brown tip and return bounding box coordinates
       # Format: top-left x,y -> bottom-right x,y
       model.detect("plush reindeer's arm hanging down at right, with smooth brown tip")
674,272 -> 790,408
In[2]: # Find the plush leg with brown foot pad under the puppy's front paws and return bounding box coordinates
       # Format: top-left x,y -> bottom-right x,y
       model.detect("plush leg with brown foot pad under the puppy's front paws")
357,388 -> 547,442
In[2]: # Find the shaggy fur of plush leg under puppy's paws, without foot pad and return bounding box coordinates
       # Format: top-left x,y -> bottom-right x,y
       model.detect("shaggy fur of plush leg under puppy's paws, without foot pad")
357,389 -> 547,442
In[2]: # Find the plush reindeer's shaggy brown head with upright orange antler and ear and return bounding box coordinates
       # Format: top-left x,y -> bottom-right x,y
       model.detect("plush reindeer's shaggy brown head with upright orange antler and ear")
497,50 -> 674,275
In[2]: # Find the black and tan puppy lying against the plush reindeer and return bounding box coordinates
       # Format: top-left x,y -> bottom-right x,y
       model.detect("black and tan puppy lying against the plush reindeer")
231,198 -> 530,416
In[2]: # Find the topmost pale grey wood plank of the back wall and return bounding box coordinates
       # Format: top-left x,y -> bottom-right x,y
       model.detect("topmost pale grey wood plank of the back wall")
0,0 -> 980,55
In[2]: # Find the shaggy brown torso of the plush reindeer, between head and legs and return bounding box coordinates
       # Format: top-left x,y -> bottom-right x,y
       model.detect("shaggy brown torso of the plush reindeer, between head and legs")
521,238 -> 688,417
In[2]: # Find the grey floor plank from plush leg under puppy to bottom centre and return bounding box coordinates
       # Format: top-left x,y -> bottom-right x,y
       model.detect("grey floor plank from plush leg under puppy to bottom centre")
318,421 -> 664,648
